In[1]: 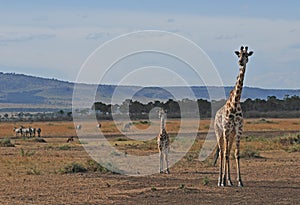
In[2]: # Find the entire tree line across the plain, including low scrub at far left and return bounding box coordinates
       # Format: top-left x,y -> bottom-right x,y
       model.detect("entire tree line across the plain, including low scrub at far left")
0,96 -> 300,122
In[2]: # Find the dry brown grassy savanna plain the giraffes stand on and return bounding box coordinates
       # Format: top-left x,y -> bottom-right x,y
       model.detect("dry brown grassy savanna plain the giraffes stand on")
0,119 -> 300,204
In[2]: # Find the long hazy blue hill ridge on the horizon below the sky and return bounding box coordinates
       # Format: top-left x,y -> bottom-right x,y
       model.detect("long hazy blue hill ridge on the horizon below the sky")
0,73 -> 300,110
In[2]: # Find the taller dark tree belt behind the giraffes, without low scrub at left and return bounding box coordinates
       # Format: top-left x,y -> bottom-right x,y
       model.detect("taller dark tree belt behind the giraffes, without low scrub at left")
92,96 -> 300,120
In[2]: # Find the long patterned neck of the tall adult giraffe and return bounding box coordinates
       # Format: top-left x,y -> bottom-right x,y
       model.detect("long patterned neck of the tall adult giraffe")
230,65 -> 246,107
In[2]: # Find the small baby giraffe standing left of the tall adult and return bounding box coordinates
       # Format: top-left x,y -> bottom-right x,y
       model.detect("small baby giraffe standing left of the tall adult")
157,109 -> 170,174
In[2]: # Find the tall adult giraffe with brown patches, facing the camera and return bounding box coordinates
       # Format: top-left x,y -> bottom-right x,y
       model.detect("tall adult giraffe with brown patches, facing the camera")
214,46 -> 253,187
